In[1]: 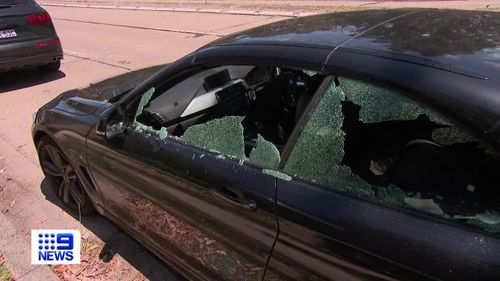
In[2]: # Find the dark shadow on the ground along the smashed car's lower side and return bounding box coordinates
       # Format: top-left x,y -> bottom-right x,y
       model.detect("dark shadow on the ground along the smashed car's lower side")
41,179 -> 182,281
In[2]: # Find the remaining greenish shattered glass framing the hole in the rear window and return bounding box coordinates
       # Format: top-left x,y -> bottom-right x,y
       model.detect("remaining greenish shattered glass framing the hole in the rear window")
283,75 -> 500,233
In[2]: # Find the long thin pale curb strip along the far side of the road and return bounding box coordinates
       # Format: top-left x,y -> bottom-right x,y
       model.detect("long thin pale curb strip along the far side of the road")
39,2 -> 318,18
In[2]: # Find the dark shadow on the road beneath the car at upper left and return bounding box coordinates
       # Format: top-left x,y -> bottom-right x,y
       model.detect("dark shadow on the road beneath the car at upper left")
0,68 -> 66,94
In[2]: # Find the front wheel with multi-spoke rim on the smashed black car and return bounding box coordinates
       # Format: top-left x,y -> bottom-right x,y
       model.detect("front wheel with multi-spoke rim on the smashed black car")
37,137 -> 94,214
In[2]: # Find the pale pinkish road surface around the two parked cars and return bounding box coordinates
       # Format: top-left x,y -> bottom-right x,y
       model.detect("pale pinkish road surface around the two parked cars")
0,7 -> 283,280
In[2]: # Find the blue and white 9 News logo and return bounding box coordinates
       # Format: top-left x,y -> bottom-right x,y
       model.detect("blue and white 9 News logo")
31,229 -> 81,264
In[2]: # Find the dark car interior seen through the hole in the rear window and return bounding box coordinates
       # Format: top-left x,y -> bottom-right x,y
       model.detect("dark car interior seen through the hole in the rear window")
342,101 -> 500,218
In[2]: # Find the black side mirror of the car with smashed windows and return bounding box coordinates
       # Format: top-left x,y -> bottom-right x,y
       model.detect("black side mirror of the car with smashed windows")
95,105 -> 126,140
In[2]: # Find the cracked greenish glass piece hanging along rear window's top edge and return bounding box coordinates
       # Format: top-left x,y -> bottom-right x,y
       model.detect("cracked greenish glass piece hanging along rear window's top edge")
339,77 -> 451,125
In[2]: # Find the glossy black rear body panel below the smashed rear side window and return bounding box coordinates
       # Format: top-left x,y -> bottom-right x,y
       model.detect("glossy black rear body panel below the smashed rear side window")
270,177 -> 500,280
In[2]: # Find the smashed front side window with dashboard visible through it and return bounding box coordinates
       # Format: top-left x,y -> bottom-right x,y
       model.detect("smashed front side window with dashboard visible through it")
135,65 -> 324,165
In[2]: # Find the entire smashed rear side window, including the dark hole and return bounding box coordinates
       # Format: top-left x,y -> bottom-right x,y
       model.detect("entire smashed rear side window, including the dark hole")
283,77 -> 500,233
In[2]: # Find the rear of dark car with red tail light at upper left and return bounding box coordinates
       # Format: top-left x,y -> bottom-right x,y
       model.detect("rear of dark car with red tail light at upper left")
0,0 -> 63,72
